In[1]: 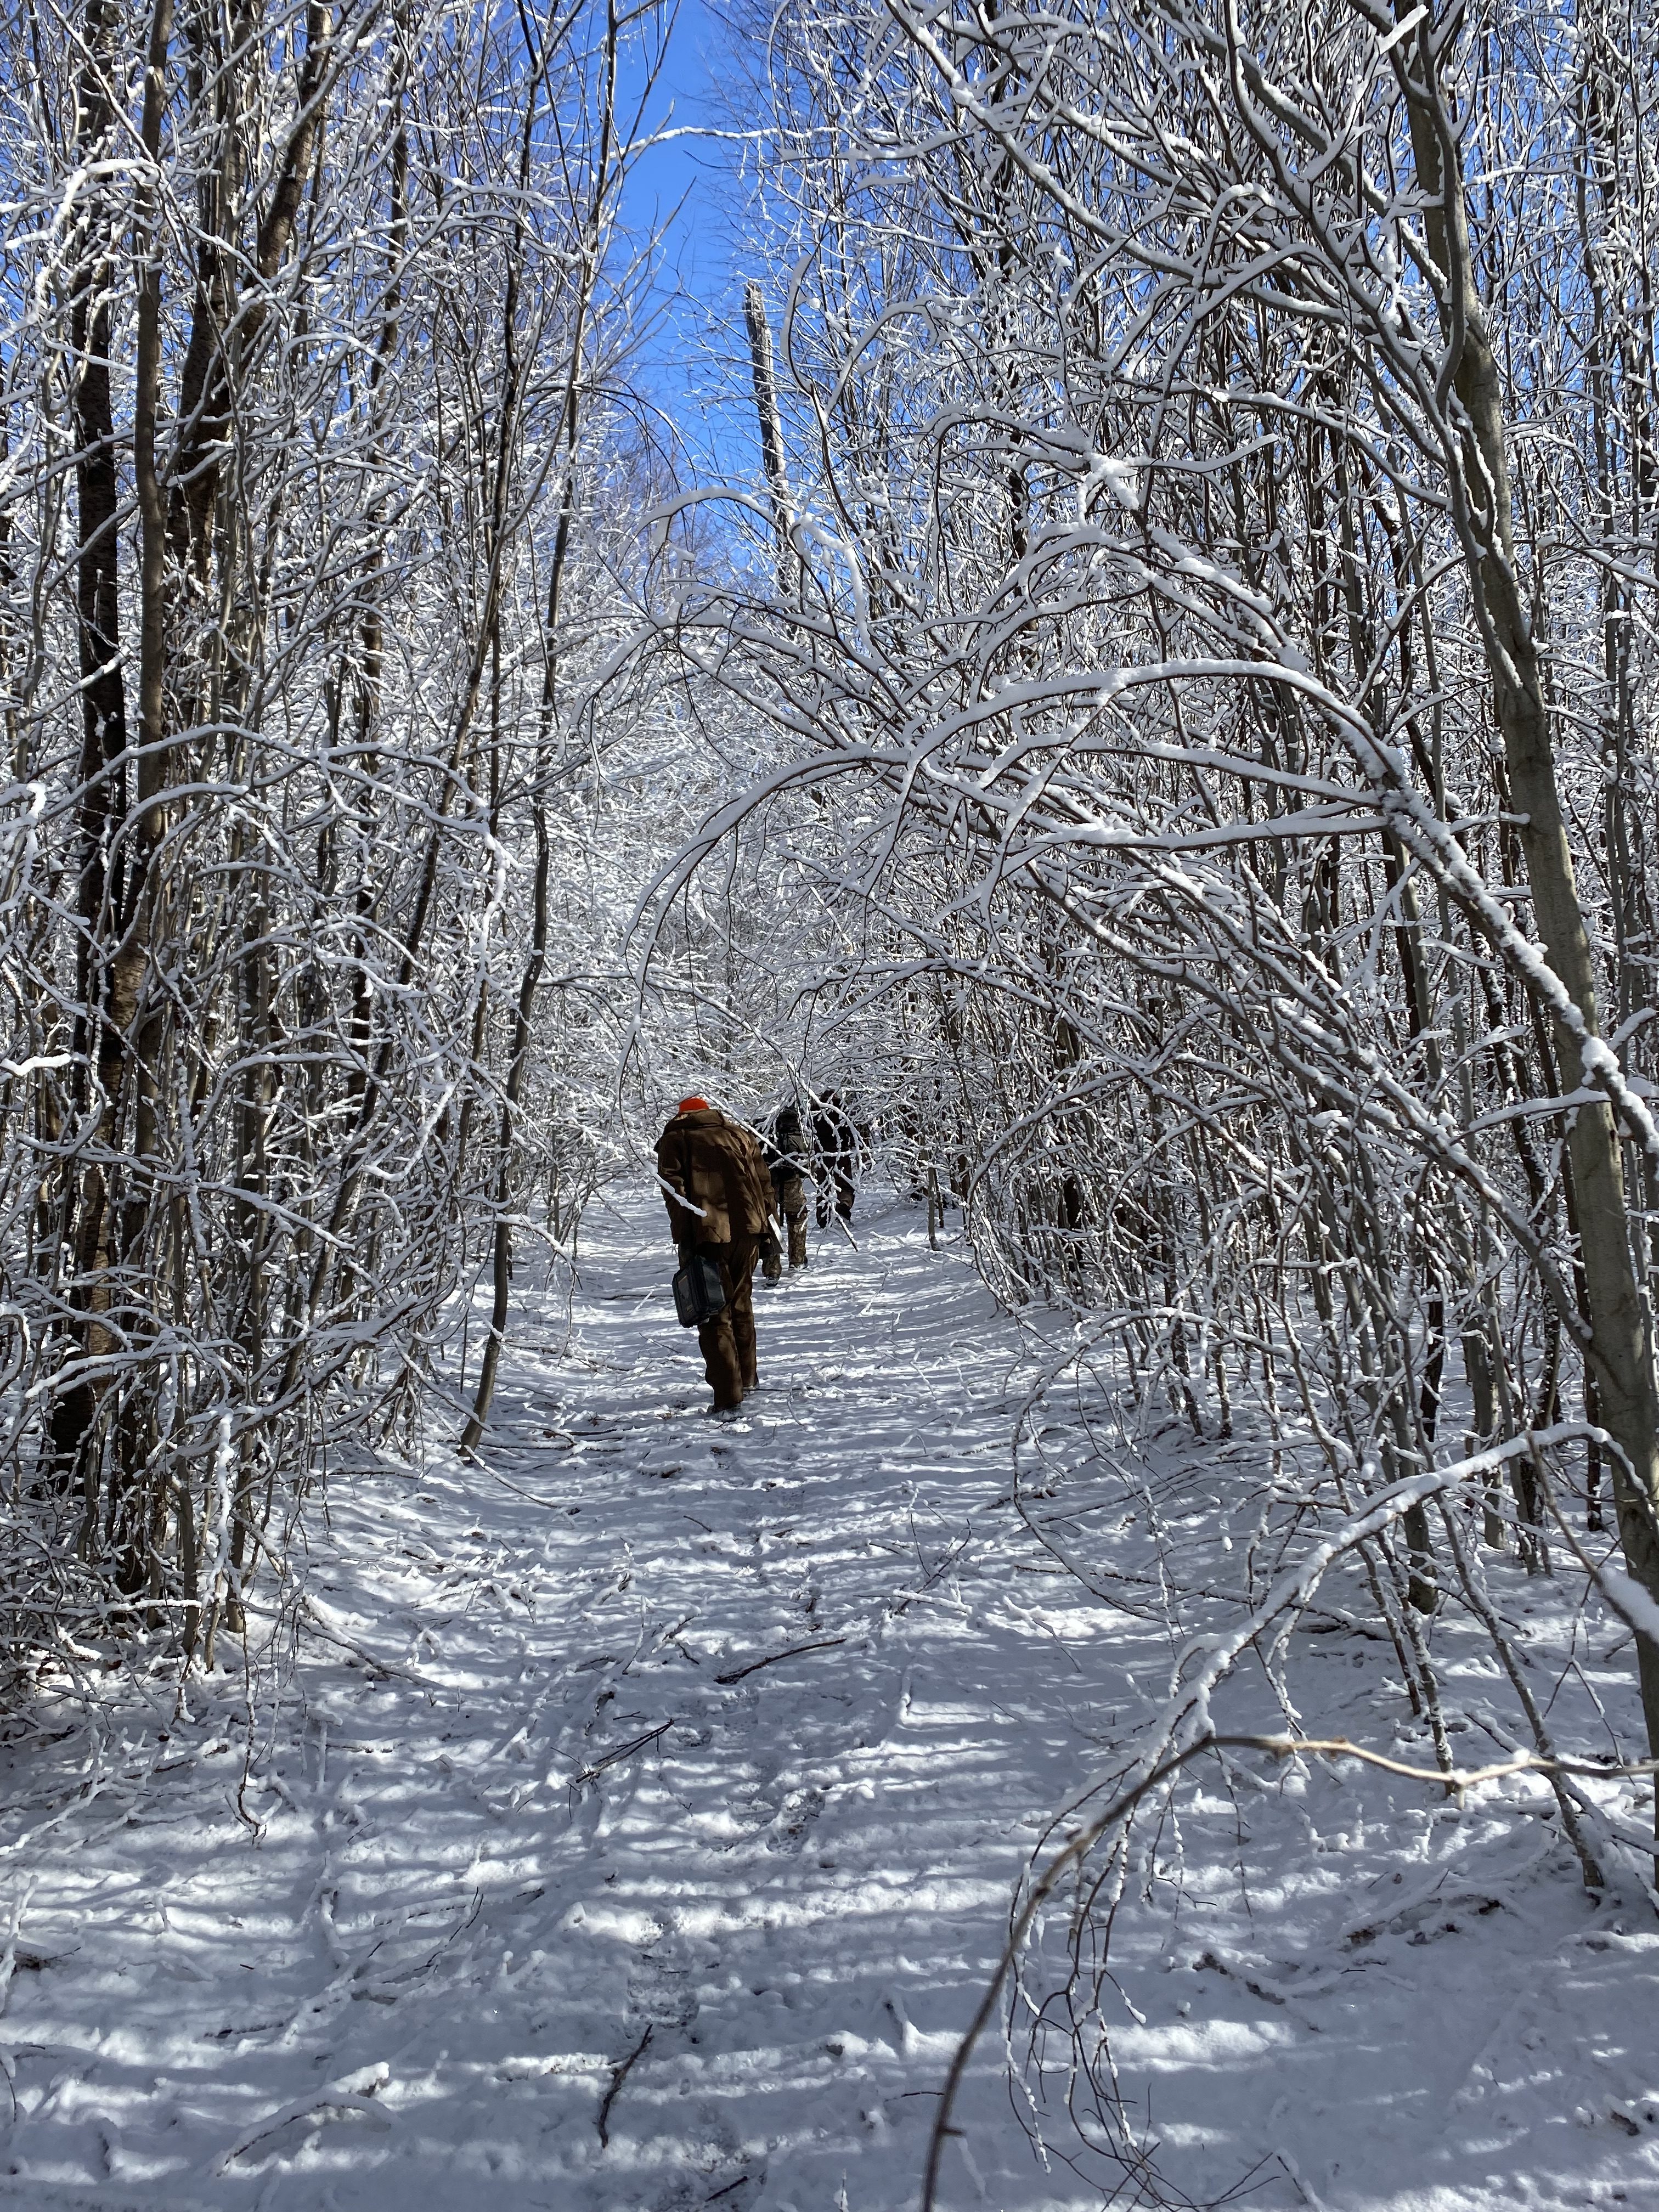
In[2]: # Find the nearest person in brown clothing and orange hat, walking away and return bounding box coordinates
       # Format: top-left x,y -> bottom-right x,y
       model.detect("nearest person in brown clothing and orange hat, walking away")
657,1097 -> 776,1413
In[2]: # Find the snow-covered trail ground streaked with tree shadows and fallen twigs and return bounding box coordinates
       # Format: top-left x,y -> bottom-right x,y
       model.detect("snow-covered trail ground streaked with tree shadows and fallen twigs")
0,1203 -> 1659,2212
